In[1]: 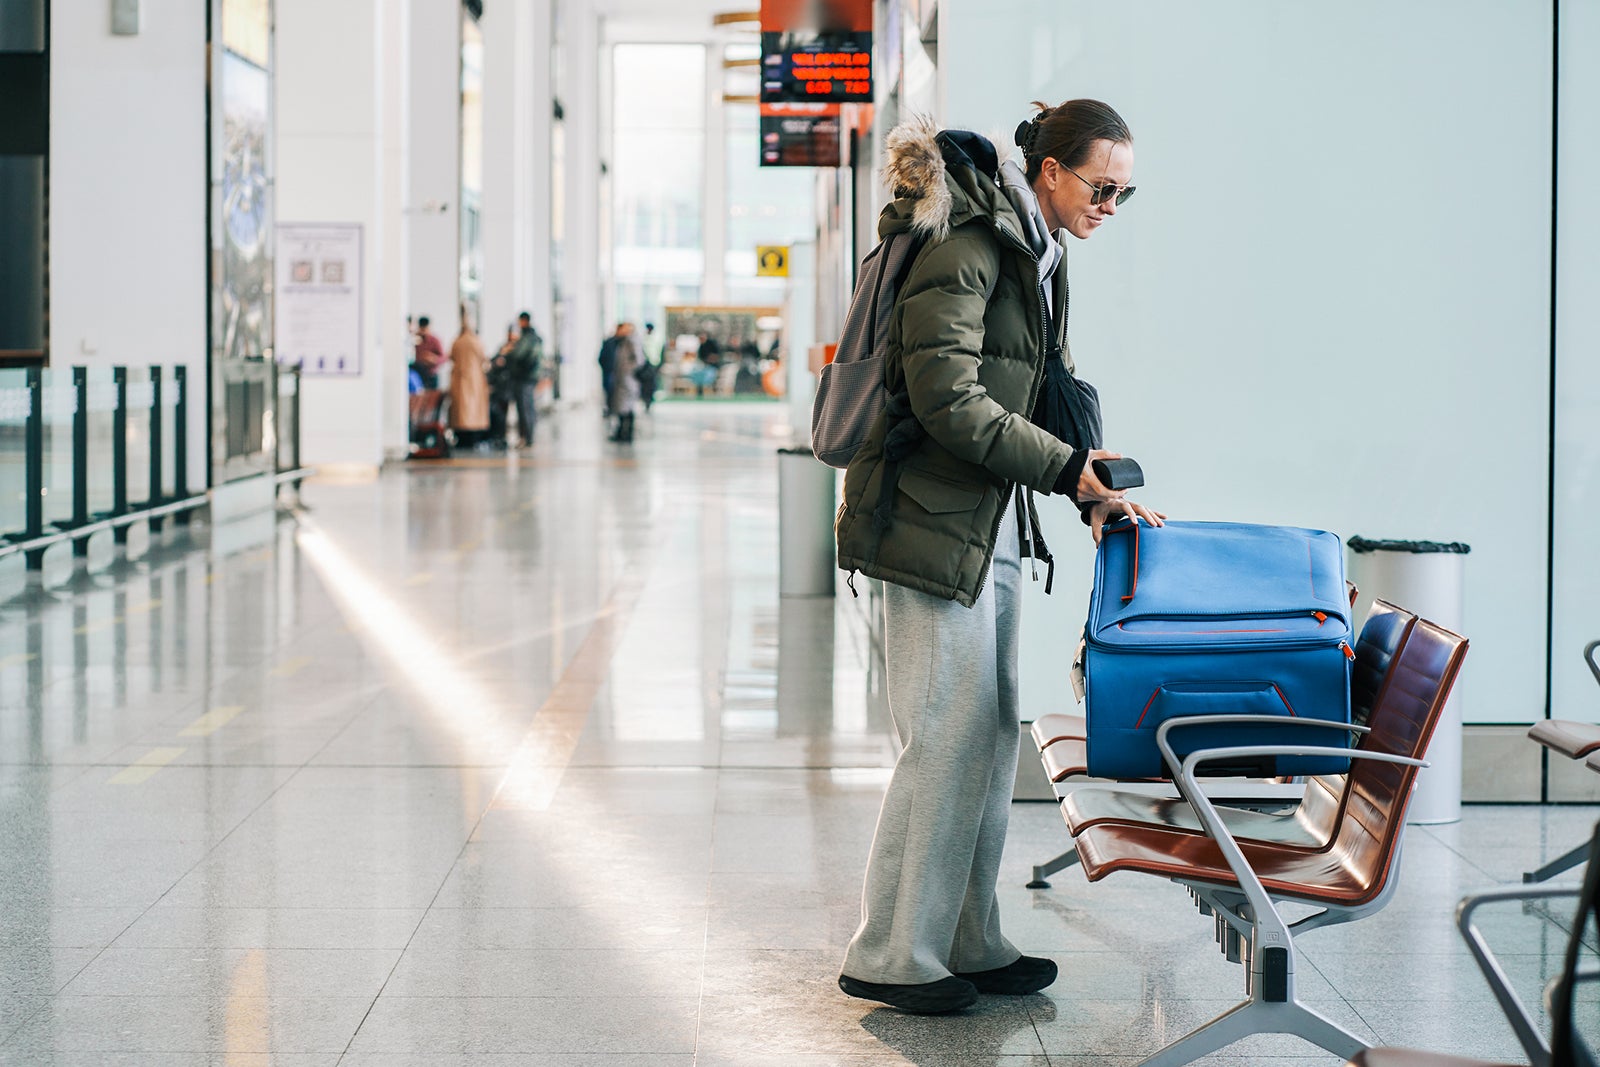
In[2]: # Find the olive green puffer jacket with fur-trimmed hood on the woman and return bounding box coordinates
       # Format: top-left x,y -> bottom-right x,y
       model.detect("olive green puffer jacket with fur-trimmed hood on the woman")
834,122 -> 1072,606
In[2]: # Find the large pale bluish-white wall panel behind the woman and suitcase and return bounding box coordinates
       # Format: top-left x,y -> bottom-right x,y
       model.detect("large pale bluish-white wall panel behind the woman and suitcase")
939,0 -> 1555,721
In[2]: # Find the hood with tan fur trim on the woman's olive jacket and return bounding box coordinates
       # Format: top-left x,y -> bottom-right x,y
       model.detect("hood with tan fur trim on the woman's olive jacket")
880,115 -> 1011,240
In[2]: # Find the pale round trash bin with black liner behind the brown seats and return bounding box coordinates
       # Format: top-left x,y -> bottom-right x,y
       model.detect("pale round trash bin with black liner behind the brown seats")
1347,537 -> 1472,824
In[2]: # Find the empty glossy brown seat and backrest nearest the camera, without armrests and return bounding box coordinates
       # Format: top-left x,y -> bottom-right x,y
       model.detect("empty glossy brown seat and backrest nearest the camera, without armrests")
1077,619 -> 1467,907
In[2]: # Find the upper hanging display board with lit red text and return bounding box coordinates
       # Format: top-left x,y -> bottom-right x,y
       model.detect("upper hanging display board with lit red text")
762,0 -> 872,104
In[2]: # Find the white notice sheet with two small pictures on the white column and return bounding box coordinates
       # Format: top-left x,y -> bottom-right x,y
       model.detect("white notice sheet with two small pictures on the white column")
274,222 -> 362,378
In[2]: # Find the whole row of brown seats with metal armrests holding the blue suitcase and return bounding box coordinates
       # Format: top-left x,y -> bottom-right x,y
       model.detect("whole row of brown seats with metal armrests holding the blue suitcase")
1035,601 -> 1467,1067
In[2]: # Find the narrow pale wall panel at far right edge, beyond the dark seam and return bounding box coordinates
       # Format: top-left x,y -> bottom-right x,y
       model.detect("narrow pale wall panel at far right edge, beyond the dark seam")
1548,3 -> 1600,721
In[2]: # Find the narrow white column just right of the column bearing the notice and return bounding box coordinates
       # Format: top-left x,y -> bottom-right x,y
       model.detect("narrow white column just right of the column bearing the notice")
406,0 -> 461,334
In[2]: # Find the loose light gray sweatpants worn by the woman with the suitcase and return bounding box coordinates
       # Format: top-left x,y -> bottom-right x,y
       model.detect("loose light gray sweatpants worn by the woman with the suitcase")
845,507 -> 1022,985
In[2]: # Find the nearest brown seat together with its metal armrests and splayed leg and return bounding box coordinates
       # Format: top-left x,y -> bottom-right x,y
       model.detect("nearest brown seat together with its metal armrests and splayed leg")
1056,606 -> 1467,1067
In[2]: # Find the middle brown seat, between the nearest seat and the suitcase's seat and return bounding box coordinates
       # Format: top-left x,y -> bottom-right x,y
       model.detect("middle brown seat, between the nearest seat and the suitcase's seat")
1058,600 -> 1416,849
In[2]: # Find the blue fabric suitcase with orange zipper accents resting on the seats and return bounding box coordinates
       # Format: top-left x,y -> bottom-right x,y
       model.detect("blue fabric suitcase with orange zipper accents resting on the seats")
1083,522 -> 1355,777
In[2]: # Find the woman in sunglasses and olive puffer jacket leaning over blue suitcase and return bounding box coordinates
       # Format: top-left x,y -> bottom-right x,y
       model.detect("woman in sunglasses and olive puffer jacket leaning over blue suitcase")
835,101 -> 1163,1013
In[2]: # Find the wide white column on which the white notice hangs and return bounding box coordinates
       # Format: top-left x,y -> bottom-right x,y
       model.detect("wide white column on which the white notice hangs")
275,0 -> 390,466
